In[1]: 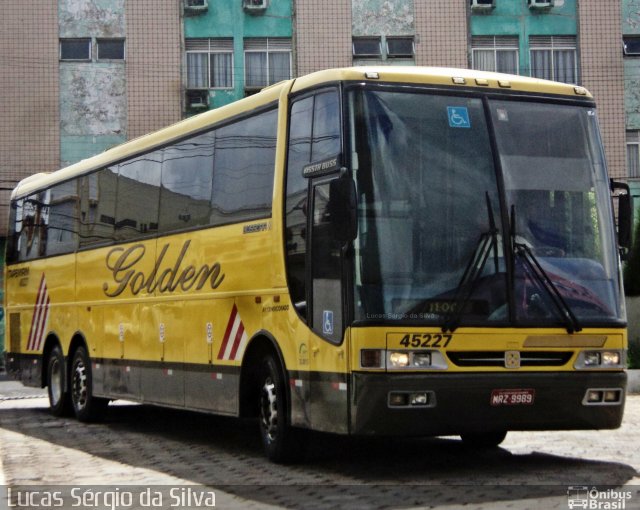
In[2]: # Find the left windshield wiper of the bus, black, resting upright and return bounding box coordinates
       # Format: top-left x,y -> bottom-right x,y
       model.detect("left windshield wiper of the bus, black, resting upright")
442,192 -> 498,333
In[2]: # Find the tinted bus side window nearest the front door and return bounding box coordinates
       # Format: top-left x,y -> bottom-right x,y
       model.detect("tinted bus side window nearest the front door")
211,110 -> 278,225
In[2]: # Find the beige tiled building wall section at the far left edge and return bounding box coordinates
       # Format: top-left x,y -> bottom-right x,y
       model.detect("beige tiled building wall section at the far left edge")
0,0 -> 60,237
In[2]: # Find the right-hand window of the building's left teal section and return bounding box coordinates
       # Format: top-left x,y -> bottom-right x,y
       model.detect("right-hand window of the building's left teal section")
244,38 -> 291,89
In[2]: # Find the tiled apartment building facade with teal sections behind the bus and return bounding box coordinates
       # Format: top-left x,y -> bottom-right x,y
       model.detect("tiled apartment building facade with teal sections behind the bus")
0,0 -> 640,231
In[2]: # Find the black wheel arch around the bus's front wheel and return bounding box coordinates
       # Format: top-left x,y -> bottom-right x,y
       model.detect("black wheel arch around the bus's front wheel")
239,330 -> 291,420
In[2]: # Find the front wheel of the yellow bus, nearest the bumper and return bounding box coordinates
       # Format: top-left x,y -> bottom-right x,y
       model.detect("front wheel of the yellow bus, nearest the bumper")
258,356 -> 302,463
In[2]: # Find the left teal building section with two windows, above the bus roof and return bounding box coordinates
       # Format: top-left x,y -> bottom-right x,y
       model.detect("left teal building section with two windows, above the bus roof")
184,0 -> 293,113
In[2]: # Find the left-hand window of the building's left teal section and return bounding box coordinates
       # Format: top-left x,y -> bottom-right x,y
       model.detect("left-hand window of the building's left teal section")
185,38 -> 233,89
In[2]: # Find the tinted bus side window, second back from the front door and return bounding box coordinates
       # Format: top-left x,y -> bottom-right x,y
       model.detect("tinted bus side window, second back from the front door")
160,132 -> 215,232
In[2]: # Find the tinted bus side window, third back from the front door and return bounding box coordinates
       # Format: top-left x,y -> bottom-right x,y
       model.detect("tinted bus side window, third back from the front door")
115,151 -> 162,240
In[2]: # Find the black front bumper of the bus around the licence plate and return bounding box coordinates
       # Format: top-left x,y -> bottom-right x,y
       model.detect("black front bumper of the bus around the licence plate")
351,371 -> 627,436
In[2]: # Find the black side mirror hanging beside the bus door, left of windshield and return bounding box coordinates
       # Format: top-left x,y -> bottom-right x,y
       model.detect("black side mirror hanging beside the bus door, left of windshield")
329,172 -> 358,244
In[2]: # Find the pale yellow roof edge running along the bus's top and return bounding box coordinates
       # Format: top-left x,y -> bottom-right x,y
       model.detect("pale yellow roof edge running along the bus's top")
11,66 -> 591,199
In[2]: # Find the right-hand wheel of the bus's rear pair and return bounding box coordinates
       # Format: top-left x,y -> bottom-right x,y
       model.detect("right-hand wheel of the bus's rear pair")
71,346 -> 109,422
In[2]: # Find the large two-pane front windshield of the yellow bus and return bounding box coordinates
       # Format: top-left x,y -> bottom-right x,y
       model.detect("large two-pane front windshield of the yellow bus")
348,89 -> 624,330
